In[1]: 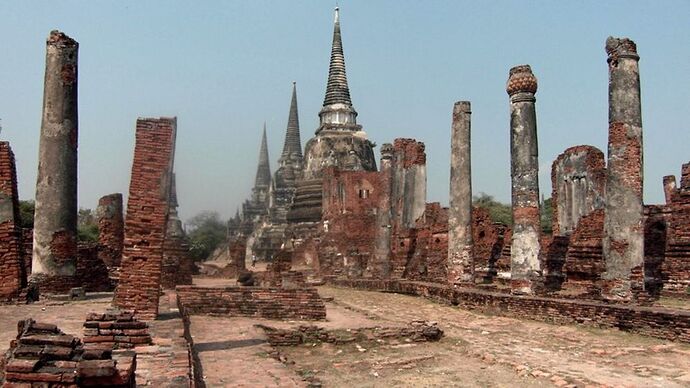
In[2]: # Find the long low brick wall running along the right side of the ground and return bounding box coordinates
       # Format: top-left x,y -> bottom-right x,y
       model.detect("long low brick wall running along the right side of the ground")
332,279 -> 690,342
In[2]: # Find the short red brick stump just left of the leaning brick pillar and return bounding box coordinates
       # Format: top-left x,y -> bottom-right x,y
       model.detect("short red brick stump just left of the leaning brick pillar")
96,193 -> 125,273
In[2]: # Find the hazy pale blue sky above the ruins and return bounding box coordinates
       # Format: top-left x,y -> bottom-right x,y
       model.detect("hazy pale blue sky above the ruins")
0,0 -> 690,224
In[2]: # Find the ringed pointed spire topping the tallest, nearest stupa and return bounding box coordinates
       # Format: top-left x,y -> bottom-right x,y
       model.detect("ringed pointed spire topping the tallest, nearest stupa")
323,7 -> 352,106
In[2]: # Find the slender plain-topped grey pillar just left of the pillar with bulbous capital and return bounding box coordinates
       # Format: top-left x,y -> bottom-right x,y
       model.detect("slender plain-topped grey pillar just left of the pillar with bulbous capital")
448,101 -> 474,284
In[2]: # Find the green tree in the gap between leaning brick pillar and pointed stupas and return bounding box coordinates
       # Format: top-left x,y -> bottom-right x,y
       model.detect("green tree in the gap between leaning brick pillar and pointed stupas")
187,210 -> 226,261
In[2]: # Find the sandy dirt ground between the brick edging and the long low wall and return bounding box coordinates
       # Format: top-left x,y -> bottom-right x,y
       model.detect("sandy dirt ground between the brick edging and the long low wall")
185,281 -> 690,387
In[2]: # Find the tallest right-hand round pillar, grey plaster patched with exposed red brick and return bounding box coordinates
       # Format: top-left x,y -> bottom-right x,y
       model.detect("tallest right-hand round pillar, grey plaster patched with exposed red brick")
601,37 -> 644,300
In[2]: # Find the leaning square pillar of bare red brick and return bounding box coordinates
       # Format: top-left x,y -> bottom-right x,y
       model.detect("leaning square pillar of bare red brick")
113,118 -> 177,319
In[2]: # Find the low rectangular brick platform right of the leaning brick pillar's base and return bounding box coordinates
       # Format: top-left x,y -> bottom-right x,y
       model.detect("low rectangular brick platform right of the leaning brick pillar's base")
176,286 -> 326,320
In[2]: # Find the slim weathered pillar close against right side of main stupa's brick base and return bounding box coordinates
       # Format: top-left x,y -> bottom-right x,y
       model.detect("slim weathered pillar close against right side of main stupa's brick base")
366,143 -> 394,279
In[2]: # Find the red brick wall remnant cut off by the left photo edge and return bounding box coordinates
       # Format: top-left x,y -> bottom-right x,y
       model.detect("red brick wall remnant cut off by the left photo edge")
0,141 -> 27,301
